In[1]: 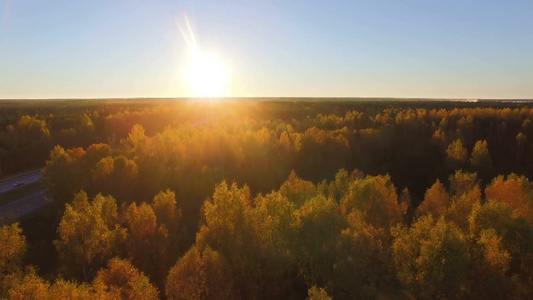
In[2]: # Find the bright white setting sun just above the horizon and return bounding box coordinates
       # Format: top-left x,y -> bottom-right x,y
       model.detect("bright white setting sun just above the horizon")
186,53 -> 226,97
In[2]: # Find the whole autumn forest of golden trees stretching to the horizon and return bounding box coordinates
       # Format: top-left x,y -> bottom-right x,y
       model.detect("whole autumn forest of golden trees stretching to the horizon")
0,99 -> 533,299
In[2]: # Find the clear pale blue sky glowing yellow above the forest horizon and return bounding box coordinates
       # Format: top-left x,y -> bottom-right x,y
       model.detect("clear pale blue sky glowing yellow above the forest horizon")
0,0 -> 533,99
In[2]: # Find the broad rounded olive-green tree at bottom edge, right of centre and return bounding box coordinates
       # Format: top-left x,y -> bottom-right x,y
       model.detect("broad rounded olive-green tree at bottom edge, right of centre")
393,216 -> 469,299
